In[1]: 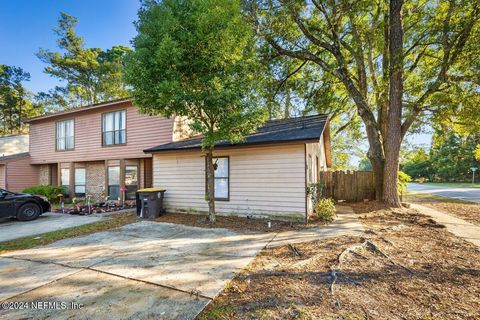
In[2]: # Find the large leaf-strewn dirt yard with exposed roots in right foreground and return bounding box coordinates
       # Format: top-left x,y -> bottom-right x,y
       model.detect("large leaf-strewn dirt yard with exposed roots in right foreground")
200,203 -> 480,319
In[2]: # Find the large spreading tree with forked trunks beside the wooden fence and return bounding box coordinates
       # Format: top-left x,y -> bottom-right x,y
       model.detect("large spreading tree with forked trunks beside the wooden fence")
249,0 -> 480,206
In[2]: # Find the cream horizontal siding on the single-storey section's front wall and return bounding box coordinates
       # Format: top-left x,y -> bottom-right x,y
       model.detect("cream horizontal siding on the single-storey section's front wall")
153,144 -> 305,220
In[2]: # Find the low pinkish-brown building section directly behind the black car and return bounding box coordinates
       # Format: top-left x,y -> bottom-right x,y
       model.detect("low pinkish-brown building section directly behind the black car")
0,152 -> 38,192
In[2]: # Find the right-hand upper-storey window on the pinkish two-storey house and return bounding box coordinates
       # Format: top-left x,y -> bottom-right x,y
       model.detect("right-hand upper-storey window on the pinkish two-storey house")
102,110 -> 127,146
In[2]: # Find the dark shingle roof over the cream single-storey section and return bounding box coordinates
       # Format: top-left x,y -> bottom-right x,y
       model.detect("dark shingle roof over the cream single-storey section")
144,114 -> 328,153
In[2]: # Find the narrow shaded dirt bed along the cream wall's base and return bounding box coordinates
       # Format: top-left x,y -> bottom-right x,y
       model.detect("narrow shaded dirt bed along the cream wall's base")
151,213 -> 325,232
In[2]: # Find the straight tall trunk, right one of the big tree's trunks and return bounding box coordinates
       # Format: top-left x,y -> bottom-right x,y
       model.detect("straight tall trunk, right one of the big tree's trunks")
383,0 -> 403,207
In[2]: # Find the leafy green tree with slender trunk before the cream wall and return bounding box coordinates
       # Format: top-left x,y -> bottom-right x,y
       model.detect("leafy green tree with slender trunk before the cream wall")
125,0 -> 265,220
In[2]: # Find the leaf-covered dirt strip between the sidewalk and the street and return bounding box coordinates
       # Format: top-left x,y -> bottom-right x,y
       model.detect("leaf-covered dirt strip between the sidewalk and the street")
406,194 -> 480,226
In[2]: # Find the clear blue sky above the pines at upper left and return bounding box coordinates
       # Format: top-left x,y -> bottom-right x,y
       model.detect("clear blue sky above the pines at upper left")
0,0 -> 140,92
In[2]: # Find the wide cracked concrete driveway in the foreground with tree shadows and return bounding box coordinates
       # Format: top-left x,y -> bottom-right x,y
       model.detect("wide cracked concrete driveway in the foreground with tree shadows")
0,221 -> 275,319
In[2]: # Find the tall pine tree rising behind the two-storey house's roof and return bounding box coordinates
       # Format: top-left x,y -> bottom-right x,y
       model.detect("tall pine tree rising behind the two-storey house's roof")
37,12 -> 130,108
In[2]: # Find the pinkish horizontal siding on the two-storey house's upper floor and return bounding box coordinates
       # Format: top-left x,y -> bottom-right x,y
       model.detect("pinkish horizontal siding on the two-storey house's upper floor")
30,102 -> 173,164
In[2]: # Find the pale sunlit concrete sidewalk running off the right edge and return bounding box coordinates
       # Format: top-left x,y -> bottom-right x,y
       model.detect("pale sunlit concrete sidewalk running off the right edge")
411,203 -> 480,248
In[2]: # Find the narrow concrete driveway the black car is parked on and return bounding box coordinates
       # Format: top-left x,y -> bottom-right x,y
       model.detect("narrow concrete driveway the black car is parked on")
0,212 -> 107,242
